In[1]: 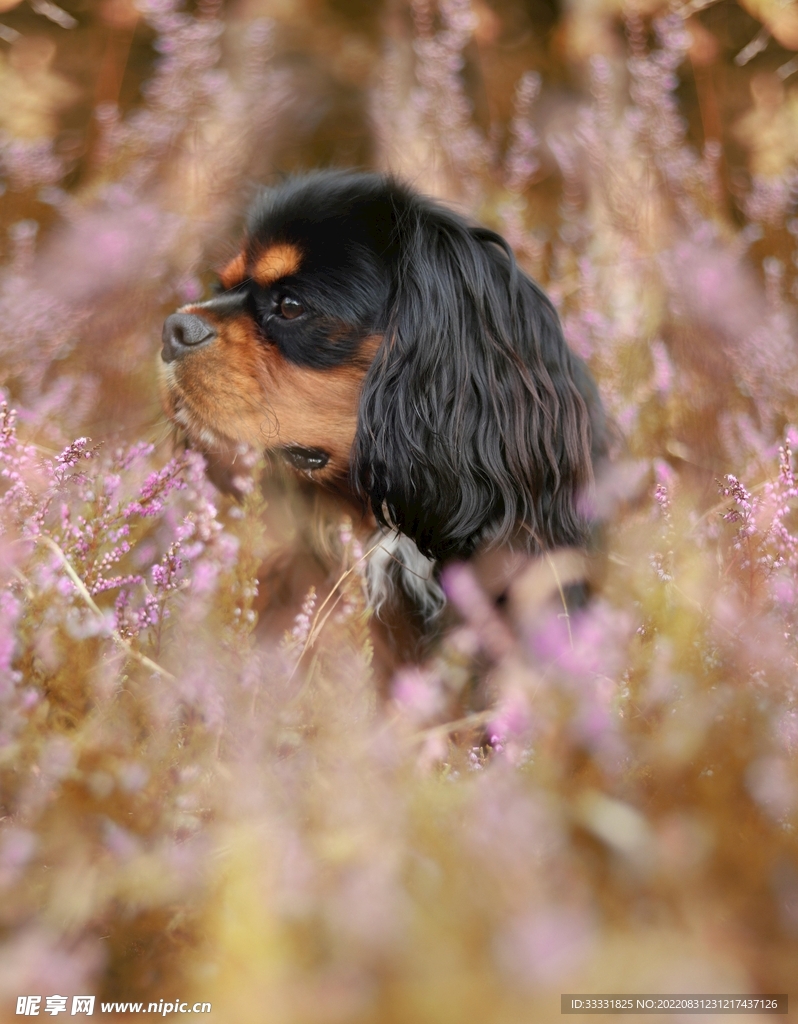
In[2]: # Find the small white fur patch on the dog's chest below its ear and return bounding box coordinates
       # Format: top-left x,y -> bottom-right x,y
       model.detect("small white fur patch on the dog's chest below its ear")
366,530 -> 446,621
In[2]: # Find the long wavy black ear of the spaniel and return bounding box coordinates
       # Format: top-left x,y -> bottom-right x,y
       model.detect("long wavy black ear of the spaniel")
353,201 -> 601,559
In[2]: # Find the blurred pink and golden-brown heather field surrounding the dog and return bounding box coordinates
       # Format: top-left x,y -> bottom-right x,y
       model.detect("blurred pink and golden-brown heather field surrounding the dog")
0,0 -> 798,1024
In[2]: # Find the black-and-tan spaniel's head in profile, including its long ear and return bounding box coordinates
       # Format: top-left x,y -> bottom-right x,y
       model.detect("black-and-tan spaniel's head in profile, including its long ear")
162,172 -> 602,559
